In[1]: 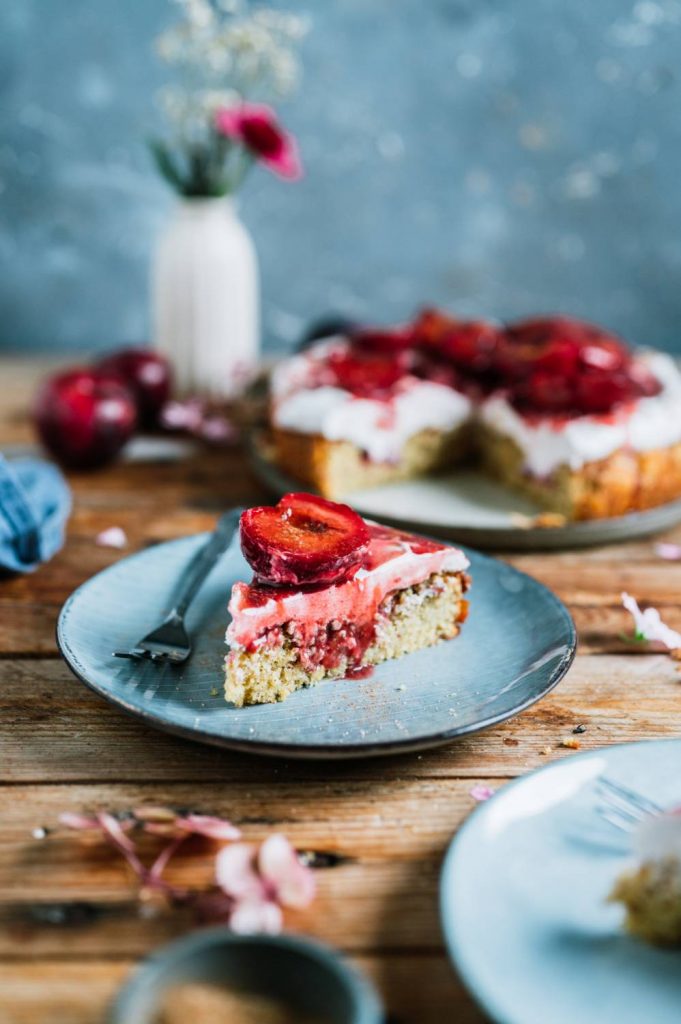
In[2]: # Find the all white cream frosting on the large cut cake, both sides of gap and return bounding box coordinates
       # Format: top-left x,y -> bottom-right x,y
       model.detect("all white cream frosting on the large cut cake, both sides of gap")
271,337 -> 681,477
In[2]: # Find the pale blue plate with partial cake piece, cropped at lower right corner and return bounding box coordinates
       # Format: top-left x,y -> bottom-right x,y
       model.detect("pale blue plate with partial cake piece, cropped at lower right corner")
441,739 -> 681,1024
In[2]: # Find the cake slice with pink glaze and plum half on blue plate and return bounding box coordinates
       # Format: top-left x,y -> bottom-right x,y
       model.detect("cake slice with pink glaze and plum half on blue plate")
225,494 -> 469,707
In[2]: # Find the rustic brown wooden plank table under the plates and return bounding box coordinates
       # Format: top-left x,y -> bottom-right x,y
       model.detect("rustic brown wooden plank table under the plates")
0,358 -> 681,1024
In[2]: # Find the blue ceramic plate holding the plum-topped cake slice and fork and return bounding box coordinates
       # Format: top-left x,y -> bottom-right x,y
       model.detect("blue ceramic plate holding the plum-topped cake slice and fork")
57,536 -> 576,758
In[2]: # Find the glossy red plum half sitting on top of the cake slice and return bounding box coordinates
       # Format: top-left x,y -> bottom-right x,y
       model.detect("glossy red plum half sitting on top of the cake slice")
240,494 -> 370,587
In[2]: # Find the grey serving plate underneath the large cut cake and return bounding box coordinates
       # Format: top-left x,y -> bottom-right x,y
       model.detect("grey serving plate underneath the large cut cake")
248,430 -> 681,551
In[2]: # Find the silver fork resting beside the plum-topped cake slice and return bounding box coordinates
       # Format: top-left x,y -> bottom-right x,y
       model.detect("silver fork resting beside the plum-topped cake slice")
114,509 -> 242,665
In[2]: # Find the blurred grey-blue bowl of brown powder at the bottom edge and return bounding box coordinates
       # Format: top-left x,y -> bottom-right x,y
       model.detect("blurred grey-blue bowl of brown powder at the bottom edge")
107,927 -> 384,1024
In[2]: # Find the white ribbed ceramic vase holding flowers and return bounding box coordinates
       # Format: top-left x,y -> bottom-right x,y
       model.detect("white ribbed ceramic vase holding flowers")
152,199 -> 260,398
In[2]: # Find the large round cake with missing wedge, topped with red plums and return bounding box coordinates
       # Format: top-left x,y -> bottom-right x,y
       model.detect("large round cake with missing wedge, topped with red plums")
270,310 -> 681,519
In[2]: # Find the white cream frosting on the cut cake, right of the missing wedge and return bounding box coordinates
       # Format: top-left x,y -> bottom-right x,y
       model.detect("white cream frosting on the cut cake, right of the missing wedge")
479,352 -> 681,477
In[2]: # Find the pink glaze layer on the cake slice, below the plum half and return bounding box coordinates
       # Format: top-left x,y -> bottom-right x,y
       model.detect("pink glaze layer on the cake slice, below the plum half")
226,523 -> 469,649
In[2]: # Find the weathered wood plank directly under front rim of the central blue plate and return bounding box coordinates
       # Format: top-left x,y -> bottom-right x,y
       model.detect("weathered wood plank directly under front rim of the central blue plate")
0,654 -> 681,782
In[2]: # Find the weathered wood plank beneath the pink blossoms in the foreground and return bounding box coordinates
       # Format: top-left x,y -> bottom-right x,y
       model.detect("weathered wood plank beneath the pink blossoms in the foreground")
0,779 -> 483,956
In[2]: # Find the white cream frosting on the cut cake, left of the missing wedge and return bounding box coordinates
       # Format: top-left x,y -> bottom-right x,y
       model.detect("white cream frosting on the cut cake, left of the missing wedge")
272,339 -> 472,462
